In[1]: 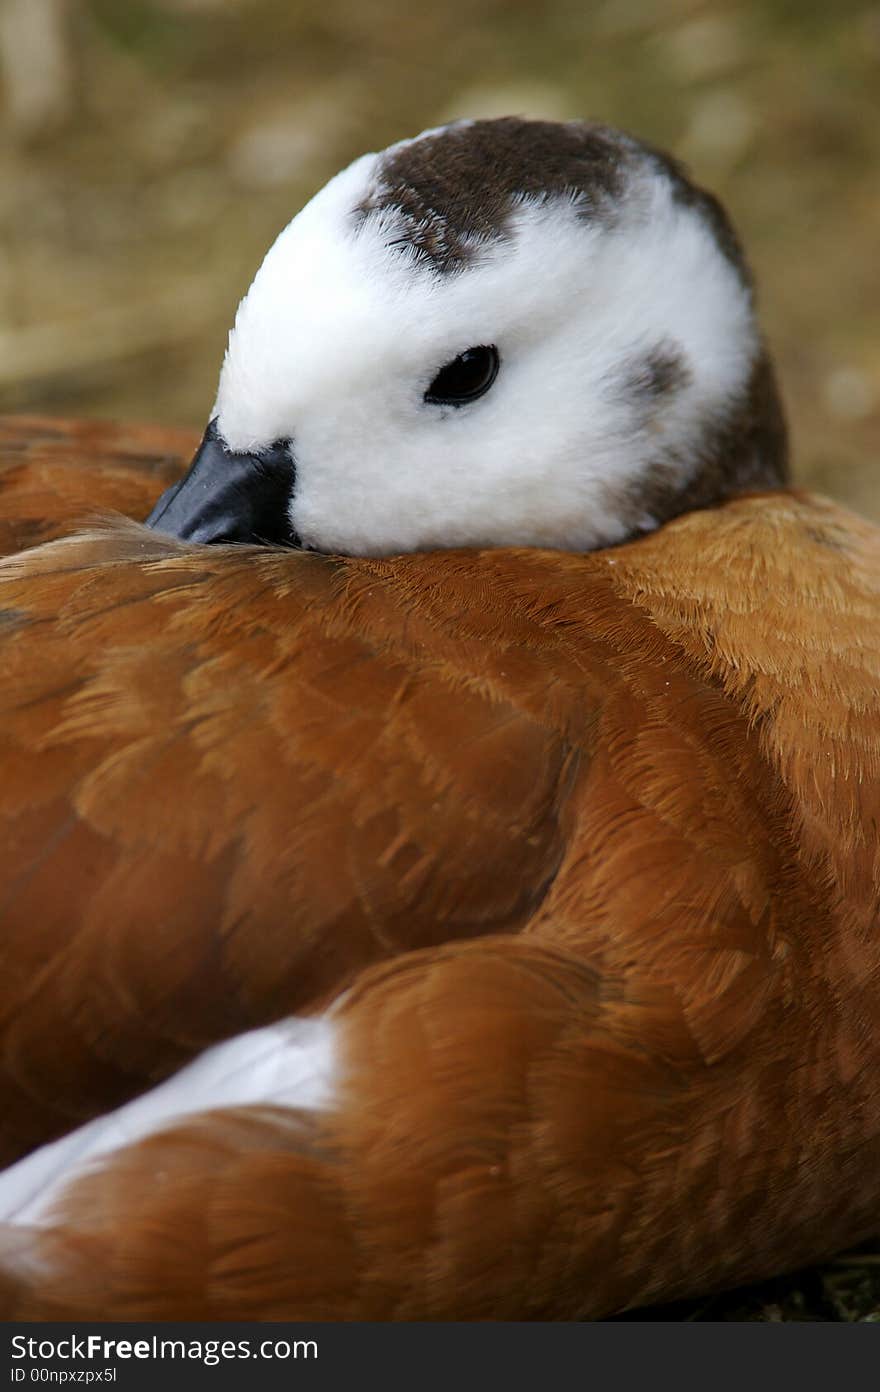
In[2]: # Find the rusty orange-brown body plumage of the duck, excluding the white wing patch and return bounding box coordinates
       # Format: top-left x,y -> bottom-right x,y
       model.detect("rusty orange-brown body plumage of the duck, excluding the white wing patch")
0,409 -> 880,1320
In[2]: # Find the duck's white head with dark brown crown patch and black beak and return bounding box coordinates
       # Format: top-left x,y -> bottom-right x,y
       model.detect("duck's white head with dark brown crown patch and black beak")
150,118 -> 785,555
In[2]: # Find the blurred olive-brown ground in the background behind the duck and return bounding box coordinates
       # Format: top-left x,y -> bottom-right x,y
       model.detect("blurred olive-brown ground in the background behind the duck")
0,0 -> 880,518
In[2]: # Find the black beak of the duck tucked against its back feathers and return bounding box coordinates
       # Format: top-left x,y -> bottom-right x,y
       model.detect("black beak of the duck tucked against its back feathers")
146,420 -> 298,546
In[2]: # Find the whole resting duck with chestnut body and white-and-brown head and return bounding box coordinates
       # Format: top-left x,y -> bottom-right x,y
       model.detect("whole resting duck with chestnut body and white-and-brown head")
0,120 -> 880,1320
